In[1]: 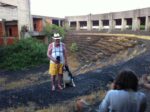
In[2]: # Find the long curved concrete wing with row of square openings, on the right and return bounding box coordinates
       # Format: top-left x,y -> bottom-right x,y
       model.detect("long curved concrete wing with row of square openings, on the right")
65,8 -> 150,31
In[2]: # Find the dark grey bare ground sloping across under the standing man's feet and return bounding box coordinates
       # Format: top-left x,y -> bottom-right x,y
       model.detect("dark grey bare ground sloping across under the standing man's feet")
0,35 -> 150,112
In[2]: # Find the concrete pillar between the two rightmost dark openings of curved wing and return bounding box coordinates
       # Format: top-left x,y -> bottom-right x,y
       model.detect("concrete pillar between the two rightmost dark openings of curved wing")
132,17 -> 140,31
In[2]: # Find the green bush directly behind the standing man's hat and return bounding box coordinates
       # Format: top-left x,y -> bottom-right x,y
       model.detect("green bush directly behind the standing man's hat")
43,23 -> 65,41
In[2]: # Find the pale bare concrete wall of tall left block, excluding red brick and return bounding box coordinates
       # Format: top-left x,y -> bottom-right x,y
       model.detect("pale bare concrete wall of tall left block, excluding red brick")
0,0 -> 33,37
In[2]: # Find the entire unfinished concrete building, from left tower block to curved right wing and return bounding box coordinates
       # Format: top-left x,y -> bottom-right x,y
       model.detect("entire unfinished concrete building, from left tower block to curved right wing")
0,0 -> 150,44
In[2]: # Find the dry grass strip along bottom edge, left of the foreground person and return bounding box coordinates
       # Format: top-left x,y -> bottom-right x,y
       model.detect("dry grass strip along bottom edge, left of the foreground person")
2,90 -> 106,112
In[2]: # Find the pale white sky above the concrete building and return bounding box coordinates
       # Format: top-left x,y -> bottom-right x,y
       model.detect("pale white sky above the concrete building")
30,0 -> 150,18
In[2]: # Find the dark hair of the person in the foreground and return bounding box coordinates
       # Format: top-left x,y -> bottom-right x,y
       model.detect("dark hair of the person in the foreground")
114,70 -> 138,91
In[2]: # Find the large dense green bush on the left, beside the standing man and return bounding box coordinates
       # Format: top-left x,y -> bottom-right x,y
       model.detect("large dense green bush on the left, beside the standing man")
0,38 -> 48,70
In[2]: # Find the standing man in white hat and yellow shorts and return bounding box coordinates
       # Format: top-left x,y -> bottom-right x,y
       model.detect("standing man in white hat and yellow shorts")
47,33 -> 67,91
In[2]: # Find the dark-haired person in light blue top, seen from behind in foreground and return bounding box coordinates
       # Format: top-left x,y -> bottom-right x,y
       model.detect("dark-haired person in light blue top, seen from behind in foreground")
99,70 -> 146,112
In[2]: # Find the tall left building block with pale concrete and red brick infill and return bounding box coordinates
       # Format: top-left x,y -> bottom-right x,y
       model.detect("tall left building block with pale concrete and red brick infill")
0,0 -> 33,38
